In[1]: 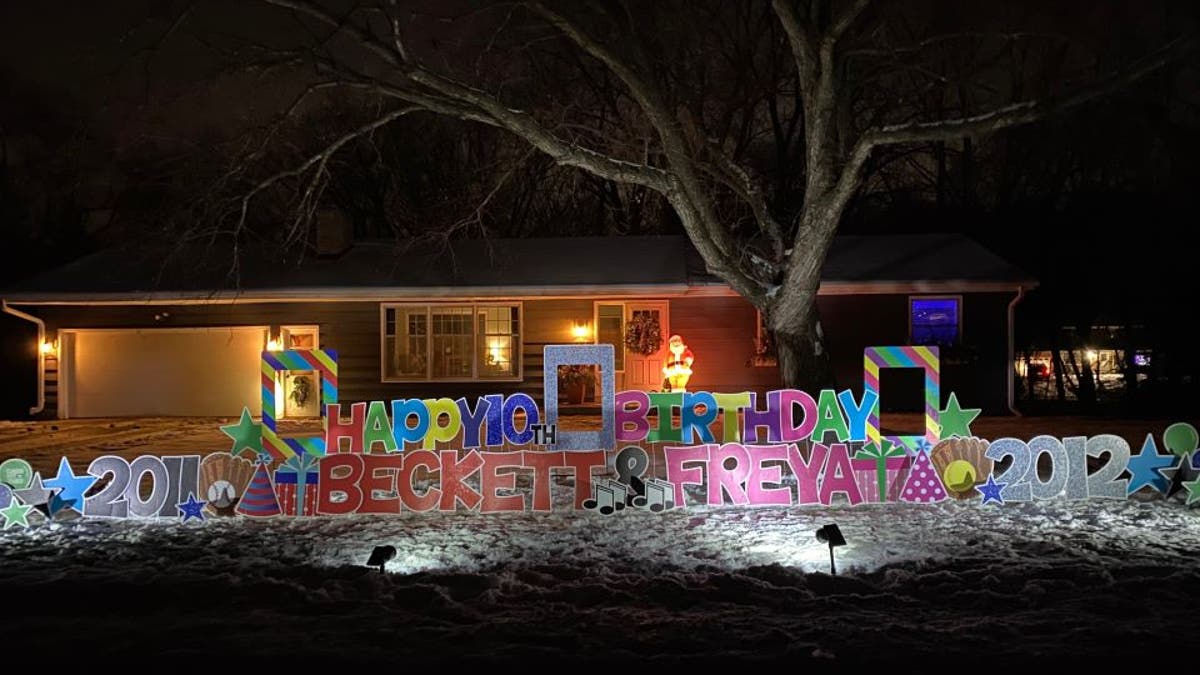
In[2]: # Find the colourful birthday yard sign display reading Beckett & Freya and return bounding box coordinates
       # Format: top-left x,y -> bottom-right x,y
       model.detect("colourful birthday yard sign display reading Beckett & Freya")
0,345 -> 1200,530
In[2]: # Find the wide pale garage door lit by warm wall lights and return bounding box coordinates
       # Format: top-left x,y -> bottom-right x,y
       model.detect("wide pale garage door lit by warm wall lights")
62,327 -> 268,417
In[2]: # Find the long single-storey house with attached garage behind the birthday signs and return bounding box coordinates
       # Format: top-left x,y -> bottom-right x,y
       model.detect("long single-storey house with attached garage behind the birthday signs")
0,234 -> 1036,418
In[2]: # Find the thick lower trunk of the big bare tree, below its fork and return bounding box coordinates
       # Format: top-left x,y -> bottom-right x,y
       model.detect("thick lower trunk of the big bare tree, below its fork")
768,292 -> 835,394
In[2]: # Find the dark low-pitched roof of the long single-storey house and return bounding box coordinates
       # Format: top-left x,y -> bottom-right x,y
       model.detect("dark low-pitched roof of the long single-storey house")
0,234 -> 1036,304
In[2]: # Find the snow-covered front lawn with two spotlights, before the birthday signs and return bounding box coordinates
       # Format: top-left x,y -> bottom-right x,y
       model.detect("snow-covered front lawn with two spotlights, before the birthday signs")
0,490 -> 1200,673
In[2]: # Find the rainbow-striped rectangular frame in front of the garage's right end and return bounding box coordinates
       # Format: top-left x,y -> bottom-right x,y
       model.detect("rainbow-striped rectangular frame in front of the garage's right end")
263,350 -> 337,460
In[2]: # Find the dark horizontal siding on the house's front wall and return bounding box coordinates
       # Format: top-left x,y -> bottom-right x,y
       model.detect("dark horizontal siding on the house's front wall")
30,293 -> 1010,416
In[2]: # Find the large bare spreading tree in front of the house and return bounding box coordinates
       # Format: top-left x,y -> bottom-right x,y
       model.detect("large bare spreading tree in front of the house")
182,0 -> 1195,387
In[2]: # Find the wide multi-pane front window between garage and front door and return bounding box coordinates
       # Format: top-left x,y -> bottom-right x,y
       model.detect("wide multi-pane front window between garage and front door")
382,304 -> 521,382
